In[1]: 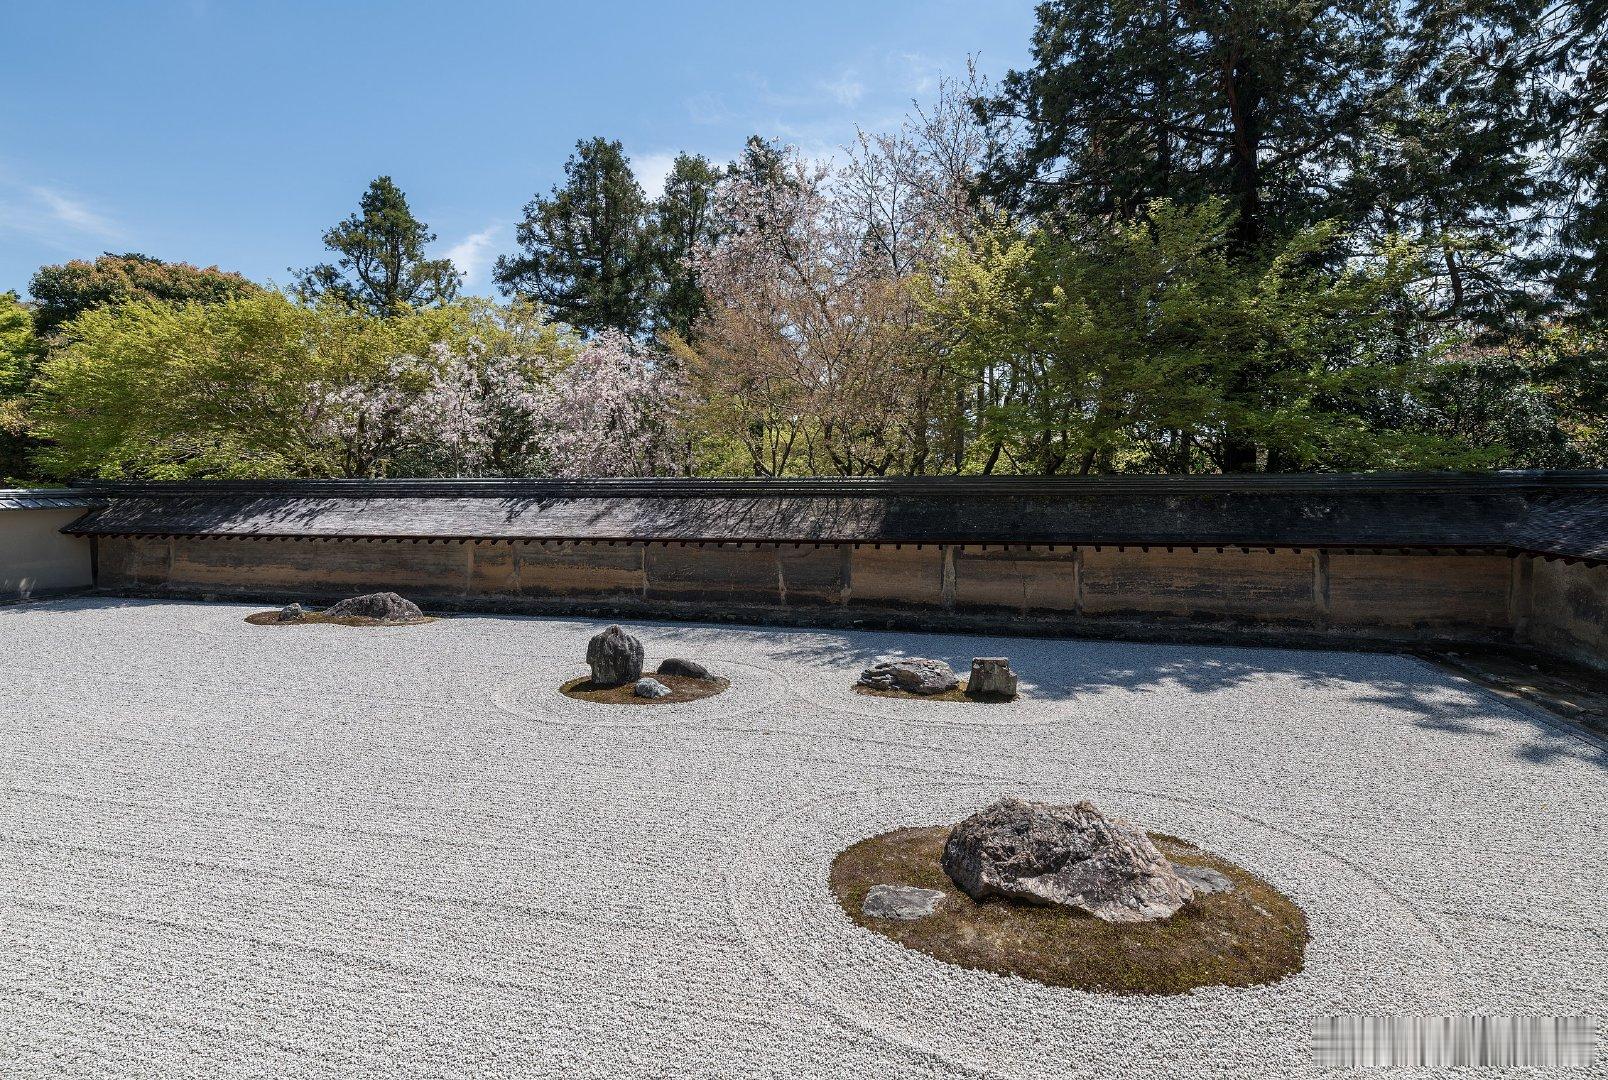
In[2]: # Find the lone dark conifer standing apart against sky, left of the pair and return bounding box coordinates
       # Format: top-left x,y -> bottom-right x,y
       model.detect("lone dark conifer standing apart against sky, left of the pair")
296,177 -> 463,317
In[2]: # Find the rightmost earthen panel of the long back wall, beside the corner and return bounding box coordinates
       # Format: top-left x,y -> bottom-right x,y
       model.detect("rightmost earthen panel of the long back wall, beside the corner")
1328,551 -> 1512,630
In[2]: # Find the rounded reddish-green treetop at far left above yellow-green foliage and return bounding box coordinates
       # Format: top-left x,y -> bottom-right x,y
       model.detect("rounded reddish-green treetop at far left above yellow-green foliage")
27,252 -> 262,338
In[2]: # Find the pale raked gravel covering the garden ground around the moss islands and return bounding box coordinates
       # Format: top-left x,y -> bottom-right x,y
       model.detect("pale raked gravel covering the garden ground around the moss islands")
0,598 -> 1608,1080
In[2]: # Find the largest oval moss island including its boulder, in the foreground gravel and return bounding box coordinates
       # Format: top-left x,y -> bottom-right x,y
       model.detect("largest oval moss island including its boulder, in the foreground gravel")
831,799 -> 1307,995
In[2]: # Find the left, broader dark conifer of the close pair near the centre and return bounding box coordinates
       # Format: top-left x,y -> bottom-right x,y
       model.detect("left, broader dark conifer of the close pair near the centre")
495,138 -> 656,338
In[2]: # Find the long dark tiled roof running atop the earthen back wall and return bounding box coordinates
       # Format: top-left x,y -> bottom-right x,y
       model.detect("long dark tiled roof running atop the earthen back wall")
68,473 -> 1608,559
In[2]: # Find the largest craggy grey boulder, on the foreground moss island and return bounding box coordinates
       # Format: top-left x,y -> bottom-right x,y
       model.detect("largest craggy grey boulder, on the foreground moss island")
942,799 -> 1195,923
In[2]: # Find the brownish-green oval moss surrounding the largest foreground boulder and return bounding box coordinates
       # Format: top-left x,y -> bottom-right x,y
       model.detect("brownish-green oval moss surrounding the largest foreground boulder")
831,826 -> 1309,995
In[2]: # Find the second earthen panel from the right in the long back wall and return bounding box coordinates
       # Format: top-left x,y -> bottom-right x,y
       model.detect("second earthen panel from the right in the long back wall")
1082,548 -> 1317,622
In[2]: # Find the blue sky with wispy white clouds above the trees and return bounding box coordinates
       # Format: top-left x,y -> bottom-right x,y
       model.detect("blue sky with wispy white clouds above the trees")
0,0 -> 1032,293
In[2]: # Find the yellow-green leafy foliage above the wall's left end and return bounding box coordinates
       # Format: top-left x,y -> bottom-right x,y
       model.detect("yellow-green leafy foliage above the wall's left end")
29,293 -> 514,479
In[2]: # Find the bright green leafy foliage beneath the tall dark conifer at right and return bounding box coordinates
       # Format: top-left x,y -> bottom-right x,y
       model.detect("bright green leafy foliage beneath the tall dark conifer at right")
921,201 -> 1471,474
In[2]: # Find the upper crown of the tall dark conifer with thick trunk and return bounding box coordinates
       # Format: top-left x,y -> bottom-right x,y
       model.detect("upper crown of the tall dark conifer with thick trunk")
978,0 -> 1394,252
